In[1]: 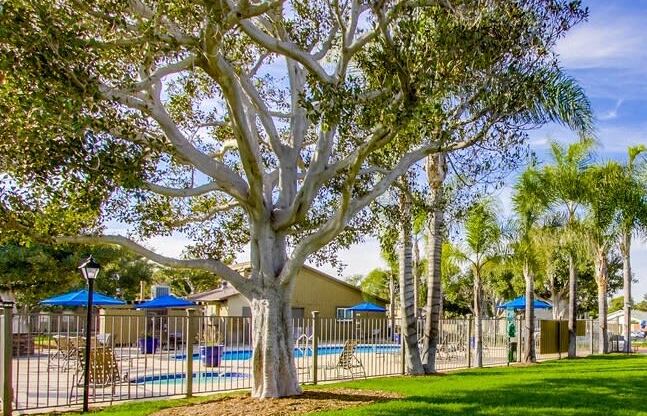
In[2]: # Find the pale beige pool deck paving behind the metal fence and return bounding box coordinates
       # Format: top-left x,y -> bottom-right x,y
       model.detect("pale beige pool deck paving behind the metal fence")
6,345 -> 506,414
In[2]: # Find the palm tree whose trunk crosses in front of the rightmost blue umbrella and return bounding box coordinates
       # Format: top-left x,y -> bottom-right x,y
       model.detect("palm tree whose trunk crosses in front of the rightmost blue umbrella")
512,165 -> 548,363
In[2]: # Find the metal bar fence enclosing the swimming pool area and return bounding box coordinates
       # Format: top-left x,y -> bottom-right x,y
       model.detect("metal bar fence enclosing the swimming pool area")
0,306 -> 604,415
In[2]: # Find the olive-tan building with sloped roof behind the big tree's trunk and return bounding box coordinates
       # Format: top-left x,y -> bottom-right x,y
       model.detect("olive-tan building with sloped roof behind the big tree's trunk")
188,264 -> 386,320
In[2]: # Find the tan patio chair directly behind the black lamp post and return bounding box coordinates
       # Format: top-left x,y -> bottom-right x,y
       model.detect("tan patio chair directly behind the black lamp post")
68,346 -> 128,403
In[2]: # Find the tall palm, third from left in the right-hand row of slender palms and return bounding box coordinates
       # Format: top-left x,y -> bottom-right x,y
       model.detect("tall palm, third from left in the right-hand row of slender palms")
541,138 -> 593,358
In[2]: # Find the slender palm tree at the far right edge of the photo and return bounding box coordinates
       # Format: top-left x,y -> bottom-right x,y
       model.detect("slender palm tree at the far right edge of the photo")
618,145 -> 647,352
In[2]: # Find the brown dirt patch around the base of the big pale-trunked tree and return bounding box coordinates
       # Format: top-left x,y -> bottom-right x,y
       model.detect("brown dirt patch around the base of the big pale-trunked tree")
153,389 -> 401,416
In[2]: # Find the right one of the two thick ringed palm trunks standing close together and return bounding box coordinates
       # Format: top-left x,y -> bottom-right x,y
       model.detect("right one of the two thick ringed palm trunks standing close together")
423,153 -> 446,374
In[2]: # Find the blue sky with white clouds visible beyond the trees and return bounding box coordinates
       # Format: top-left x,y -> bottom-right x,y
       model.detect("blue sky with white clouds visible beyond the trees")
148,0 -> 647,300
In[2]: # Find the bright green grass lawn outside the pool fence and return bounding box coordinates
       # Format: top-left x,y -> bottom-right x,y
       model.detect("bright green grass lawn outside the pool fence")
62,355 -> 647,416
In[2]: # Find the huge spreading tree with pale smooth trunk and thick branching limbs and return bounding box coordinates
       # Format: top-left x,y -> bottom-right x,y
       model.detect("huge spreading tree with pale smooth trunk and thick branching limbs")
0,0 -> 586,397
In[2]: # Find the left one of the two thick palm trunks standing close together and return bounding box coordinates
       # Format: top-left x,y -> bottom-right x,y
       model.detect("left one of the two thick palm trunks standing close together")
399,195 -> 425,375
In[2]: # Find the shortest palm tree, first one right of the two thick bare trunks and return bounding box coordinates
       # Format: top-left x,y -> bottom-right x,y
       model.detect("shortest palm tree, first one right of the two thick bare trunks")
454,200 -> 502,367
